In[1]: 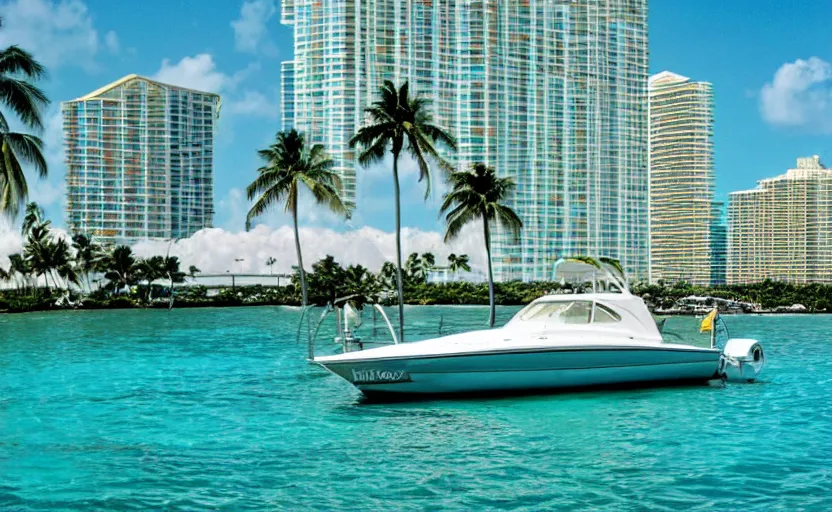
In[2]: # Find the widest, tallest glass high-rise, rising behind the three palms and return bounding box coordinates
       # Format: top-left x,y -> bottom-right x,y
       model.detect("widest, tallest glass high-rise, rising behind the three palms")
281,0 -> 648,280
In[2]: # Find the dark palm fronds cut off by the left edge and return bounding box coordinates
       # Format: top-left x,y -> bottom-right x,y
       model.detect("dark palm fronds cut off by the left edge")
0,33 -> 49,217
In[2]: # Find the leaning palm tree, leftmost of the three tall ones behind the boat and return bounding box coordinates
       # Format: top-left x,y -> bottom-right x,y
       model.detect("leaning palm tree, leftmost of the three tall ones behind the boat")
246,129 -> 350,306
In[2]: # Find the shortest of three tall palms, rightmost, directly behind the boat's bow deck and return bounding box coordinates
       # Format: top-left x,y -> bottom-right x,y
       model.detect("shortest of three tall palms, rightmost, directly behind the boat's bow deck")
440,163 -> 523,327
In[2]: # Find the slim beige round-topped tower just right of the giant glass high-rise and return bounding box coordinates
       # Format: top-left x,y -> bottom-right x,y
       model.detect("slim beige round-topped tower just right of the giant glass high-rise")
649,71 -> 714,285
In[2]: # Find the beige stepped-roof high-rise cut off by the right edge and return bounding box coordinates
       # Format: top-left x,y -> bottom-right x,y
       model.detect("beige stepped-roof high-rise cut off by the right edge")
727,156 -> 832,284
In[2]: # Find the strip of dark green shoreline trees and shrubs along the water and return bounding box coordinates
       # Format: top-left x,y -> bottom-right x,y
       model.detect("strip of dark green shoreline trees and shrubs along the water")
0,234 -> 832,312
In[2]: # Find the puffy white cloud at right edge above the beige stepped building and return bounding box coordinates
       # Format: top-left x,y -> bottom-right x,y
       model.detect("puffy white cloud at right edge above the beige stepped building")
760,57 -> 832,133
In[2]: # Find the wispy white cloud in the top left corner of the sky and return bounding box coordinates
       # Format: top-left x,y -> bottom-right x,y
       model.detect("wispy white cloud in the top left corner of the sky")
0,0 -> 115,69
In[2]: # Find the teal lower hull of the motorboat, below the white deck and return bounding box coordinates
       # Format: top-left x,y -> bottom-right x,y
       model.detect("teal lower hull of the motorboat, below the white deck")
319,346 -> 720,396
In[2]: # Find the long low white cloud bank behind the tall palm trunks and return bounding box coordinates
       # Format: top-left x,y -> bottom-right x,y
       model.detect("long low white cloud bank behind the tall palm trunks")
133,224 -> 485,274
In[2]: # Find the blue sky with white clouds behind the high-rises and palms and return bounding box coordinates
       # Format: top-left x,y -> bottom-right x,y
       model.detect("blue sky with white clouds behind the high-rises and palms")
0,0 -> 832,271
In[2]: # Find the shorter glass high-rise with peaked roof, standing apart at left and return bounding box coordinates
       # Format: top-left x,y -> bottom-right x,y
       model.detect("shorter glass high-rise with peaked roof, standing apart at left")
61,75 -> 220,243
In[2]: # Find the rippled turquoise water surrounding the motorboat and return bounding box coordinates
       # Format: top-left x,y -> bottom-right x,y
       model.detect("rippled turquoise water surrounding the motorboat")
0,307 -> 832,511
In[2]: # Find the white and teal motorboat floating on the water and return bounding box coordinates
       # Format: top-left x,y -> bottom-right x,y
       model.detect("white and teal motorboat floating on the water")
313,260 -> 764,396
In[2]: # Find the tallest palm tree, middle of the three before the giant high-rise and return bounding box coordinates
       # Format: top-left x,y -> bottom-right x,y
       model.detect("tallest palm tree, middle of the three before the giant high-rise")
350,80 -> 456,341
